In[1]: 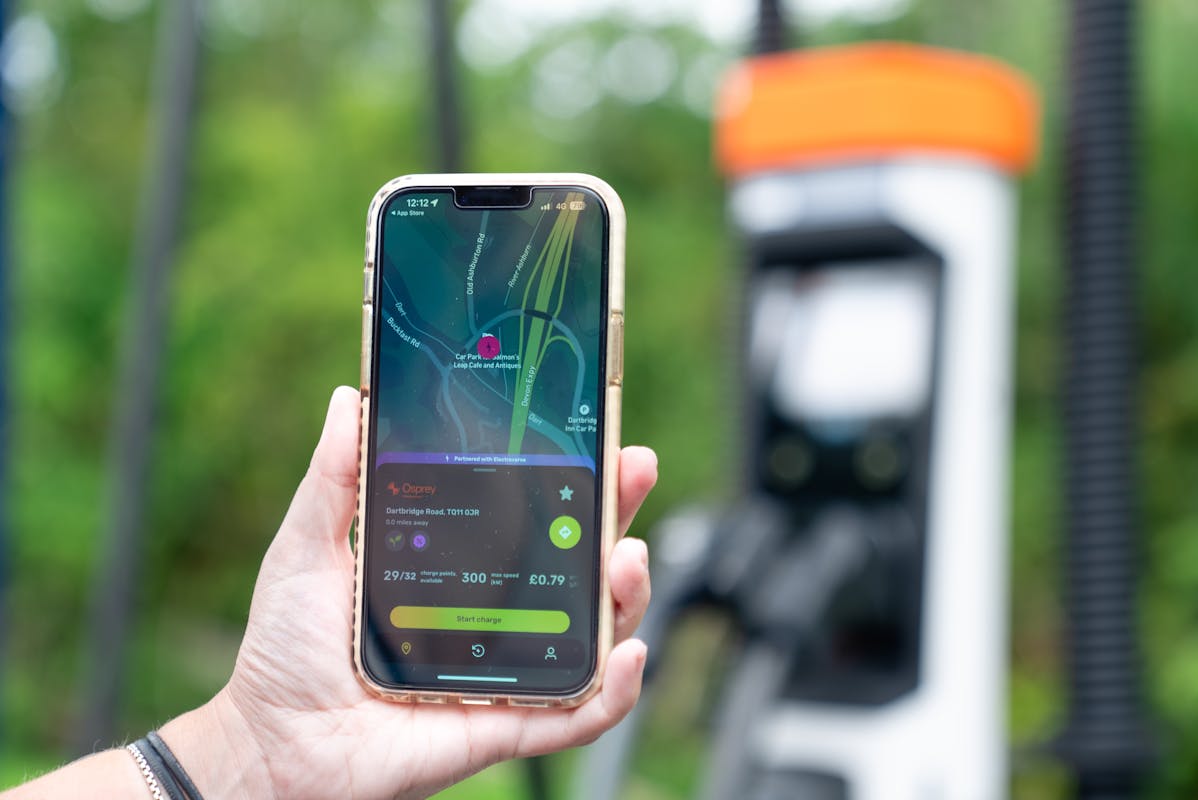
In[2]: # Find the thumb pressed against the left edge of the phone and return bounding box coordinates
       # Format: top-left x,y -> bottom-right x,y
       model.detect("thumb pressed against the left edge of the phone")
279,386 -> 362,543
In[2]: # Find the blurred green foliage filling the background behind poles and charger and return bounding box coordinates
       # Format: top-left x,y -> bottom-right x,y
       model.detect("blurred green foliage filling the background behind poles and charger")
0,0 -> 1198,798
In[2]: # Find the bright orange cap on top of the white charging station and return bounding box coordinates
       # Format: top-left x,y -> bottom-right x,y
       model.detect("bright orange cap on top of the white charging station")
715,43 -> 1039,176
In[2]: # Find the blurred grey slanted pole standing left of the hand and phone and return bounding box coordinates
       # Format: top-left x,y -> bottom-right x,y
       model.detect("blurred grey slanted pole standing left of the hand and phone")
75,0 -> 200,752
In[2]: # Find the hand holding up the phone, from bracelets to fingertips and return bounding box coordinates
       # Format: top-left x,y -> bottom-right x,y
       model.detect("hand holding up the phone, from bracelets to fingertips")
162,387 -> 657,800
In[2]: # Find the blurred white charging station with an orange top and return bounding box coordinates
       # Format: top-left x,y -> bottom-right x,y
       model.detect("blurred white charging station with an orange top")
710,44 -> 1036,800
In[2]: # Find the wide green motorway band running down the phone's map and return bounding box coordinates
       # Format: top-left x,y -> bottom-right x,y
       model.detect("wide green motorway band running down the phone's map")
508,192 -> 582,454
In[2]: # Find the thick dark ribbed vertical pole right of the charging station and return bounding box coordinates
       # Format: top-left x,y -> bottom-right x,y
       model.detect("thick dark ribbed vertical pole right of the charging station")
1060,0 -> 1152,800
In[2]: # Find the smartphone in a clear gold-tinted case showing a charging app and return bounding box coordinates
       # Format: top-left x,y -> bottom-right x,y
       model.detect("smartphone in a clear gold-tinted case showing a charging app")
353,174 -> 624,705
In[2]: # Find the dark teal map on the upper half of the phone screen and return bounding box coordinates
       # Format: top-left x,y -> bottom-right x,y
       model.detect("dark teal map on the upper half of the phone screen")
375,189 -> 606,471
